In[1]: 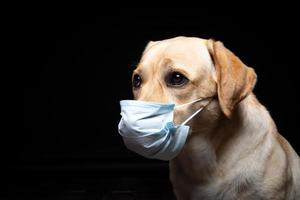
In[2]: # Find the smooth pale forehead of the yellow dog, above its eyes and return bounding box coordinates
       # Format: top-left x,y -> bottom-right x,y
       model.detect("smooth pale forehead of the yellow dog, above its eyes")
141,36 -> 212,70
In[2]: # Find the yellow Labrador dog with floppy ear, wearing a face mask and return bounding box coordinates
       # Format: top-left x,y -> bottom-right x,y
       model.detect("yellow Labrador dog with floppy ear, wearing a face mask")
133,36 -> 300,200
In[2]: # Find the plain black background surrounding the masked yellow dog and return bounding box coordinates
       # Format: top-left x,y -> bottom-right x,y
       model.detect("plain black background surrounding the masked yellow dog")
1,6 -> 300,199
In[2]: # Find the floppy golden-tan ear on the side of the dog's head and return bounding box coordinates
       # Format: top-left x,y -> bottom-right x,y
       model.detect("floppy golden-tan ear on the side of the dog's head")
207,40 -> 256,117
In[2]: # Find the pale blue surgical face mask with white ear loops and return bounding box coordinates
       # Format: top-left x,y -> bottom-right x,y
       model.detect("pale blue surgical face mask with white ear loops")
118,99 -> 209,160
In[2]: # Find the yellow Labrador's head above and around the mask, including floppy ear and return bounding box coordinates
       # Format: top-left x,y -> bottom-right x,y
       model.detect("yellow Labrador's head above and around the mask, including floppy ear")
132,37 -> 256,128
